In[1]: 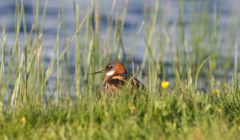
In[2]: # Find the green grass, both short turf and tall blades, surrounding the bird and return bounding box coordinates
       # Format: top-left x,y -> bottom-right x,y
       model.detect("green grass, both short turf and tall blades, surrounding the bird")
0,0 -> 240,139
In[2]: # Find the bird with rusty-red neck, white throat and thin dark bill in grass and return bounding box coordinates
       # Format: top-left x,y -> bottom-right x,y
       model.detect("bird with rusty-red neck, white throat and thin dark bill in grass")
91,61 -> 144,95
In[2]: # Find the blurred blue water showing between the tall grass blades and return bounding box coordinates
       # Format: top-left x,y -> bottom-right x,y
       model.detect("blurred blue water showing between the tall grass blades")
0,0 -> 240,91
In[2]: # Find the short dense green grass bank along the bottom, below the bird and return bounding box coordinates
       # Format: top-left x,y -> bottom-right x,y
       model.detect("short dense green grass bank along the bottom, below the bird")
0,87 -> 240,139
